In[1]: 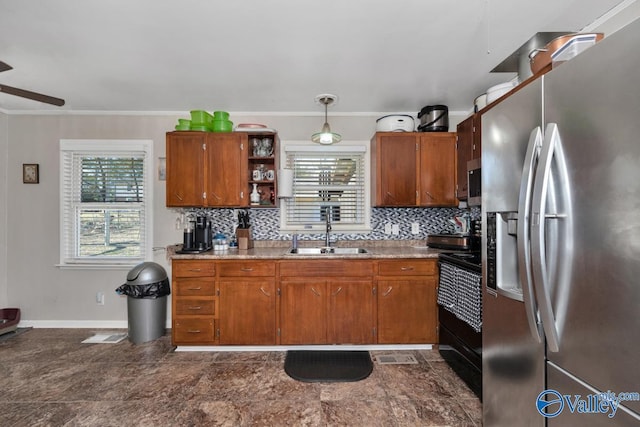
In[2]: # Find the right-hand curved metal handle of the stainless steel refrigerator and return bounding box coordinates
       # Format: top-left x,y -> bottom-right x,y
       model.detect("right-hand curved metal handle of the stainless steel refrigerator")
531,123 -> 571,352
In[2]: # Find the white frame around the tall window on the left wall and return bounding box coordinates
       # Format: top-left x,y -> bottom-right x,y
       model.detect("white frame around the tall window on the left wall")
58,139 -> 154,269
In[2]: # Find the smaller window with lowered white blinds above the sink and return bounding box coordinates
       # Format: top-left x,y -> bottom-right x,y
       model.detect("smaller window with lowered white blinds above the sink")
281,146 -> 370,232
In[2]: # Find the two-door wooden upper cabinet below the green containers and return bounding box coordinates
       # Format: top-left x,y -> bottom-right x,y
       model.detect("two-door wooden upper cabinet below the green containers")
166,132 -> 248,207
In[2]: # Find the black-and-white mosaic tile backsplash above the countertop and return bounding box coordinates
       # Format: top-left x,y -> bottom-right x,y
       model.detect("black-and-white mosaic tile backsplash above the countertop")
180,207 -> 480,240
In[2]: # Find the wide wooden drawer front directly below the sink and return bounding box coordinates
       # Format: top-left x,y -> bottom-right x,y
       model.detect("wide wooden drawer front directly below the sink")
280,260 -> 373,277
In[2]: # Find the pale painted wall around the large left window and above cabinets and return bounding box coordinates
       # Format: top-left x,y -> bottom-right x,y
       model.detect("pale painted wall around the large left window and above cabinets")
0,113 -> 465,327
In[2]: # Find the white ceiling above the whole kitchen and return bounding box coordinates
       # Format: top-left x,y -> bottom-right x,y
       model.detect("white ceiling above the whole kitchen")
0,0 -> 622,114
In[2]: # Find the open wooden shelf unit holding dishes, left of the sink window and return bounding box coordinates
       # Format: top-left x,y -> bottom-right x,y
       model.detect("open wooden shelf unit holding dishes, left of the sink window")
247,132 -> 279,208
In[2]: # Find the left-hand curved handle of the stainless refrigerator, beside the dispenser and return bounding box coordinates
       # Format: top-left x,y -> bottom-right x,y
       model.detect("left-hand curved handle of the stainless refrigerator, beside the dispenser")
516,126 -> 542,342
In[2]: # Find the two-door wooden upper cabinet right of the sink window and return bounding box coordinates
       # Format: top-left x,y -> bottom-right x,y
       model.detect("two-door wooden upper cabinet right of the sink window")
372,132 -> 458,207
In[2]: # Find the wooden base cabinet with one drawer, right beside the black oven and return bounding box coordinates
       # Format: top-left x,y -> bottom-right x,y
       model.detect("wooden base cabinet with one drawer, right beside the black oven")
376,259 -> 438,344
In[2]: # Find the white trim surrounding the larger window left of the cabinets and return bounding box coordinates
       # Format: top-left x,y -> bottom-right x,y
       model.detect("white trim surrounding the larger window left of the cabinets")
57,139 -> 154,269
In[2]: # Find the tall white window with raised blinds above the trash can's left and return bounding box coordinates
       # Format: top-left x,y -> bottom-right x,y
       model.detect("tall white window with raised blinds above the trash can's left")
60,140 -> 153,266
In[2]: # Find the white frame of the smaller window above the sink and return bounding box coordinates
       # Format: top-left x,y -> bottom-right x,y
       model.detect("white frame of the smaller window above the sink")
278,141 -> 371,234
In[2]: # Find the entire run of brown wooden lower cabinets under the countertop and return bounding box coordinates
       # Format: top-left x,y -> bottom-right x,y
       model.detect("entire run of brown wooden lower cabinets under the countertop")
172,259 -> 438,345
